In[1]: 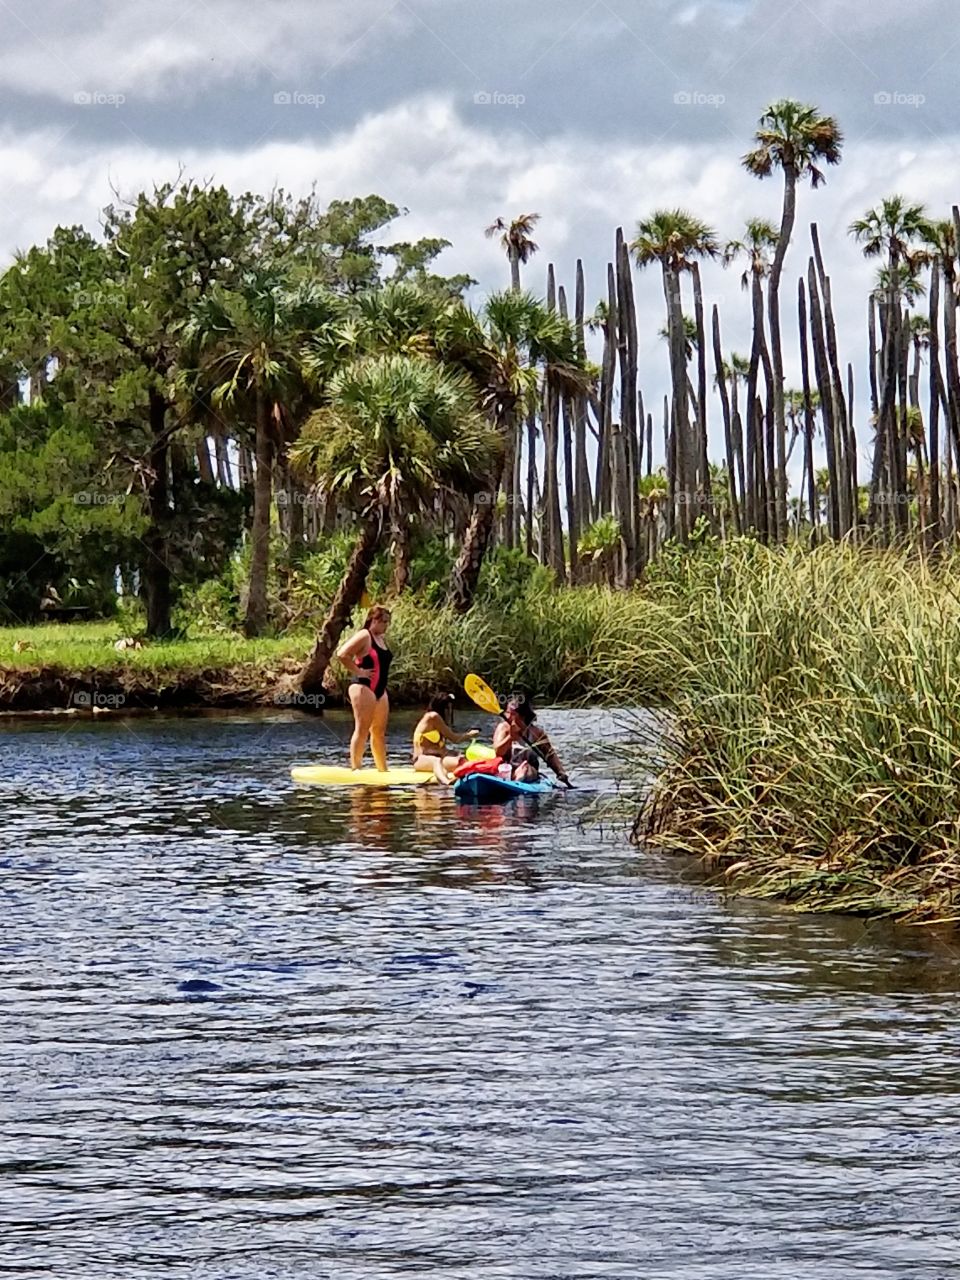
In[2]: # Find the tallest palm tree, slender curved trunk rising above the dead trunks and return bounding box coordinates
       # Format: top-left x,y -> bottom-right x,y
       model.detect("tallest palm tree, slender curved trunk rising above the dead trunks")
742,99 -> 844,536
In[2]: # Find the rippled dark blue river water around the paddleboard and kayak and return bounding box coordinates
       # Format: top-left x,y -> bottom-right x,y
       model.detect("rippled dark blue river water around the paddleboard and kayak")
0,712 -> 960,1280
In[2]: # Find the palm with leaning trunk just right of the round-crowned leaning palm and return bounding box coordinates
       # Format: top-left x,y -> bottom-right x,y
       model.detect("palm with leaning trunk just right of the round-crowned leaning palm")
436,291 -> 591,612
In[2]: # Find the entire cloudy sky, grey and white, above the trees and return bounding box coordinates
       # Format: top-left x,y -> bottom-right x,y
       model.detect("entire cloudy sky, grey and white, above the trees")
0,0 -> 960,471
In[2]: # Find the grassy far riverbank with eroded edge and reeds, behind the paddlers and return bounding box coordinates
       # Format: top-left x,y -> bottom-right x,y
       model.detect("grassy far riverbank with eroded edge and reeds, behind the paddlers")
0,588 -> 662,713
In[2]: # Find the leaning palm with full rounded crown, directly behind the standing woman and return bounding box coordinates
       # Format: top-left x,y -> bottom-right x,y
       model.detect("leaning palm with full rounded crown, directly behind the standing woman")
291,355 -> 499,692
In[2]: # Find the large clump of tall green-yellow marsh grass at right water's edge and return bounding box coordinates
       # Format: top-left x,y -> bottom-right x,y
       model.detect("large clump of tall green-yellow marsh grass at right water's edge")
635,544 -> 960,920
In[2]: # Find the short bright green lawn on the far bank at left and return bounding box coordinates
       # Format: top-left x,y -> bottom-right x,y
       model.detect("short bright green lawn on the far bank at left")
0,622 -> 312,673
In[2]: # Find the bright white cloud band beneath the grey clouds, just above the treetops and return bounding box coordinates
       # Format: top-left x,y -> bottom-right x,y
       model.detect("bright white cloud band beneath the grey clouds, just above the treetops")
0,88 -> 956,481
